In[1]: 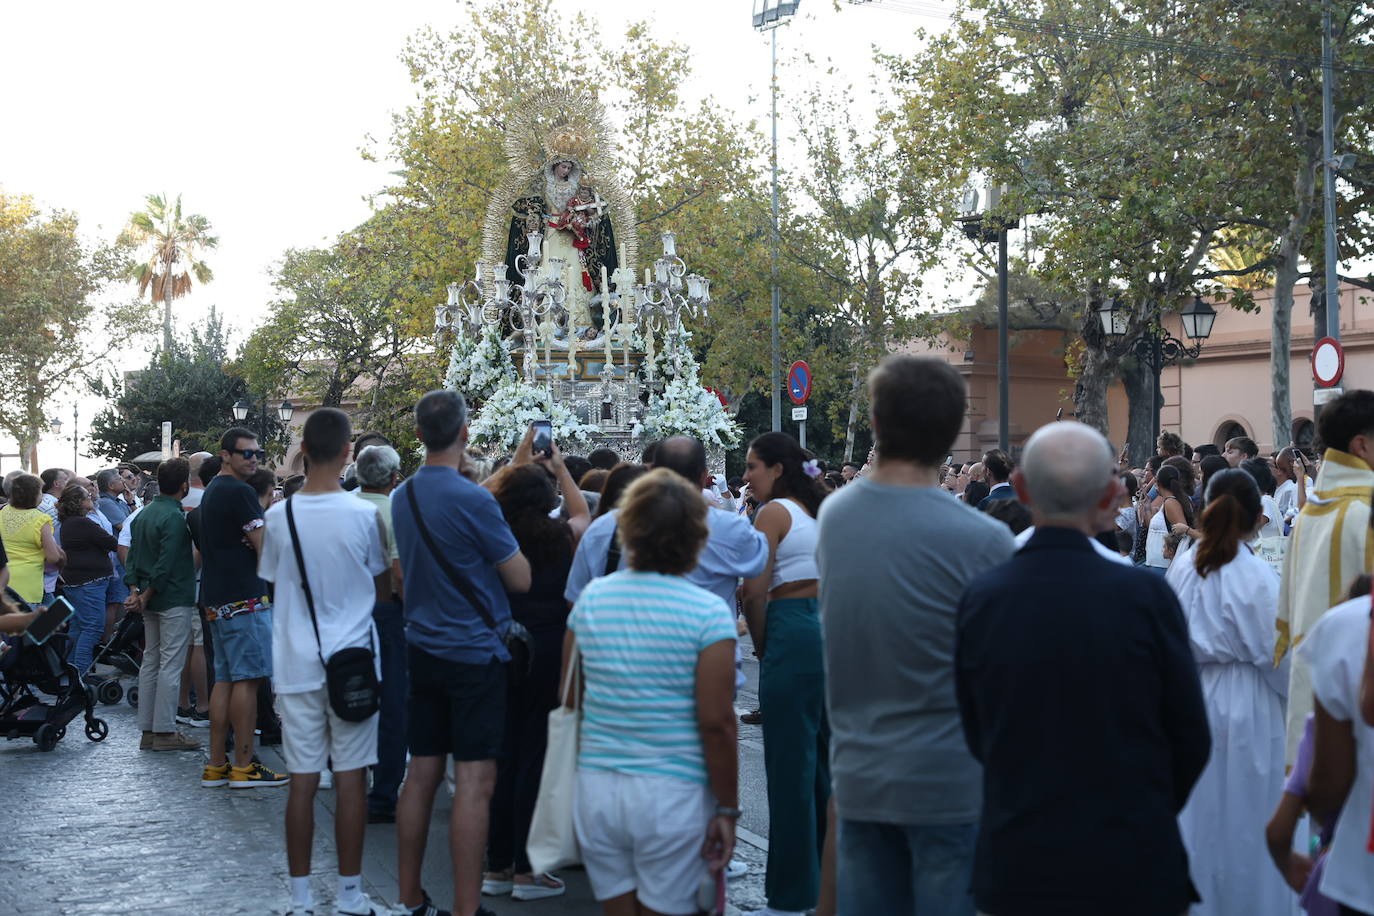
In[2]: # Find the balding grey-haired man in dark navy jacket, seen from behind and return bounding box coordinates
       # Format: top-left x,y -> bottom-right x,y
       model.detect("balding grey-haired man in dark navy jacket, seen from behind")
955,423 -> 1210,916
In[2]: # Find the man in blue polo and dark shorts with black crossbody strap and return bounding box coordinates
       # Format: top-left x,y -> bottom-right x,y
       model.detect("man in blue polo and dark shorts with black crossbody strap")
392,390 -> 530,916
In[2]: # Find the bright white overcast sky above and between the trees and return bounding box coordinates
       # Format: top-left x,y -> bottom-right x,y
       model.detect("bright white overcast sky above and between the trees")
0,0 -> 947,470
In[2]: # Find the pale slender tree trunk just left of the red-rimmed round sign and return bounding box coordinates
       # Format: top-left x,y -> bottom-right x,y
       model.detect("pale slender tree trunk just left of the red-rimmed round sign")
1270,131 -> 1323,449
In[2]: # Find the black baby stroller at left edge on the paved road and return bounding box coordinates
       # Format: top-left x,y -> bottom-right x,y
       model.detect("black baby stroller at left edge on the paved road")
0,589 -> 110,751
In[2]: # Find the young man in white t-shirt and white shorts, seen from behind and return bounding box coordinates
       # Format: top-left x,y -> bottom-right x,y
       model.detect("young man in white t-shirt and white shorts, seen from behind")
258,408 -> 389,916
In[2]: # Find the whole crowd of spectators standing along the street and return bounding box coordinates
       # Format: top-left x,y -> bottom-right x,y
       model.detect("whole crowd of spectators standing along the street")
0,356 -> 1374,916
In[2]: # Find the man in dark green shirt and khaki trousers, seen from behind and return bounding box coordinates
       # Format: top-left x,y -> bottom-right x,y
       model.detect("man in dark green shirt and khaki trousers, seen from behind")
124,457 -> 201,751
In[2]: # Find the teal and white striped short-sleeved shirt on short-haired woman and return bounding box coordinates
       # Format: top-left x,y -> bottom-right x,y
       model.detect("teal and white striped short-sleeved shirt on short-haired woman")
567,570 -> 735,784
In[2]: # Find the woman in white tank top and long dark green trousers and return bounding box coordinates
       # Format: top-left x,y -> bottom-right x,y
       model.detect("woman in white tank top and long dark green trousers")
745,433 -> 830,916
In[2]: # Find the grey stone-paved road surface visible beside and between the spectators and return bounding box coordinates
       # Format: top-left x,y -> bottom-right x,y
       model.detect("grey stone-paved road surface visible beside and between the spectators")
0,645 -> 768,916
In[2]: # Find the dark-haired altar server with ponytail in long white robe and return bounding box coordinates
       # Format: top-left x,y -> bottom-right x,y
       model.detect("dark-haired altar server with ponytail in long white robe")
1168,470 -> 1296,916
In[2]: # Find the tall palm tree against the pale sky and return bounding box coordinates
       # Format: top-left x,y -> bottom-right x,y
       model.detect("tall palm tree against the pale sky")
121,194 -> 220,350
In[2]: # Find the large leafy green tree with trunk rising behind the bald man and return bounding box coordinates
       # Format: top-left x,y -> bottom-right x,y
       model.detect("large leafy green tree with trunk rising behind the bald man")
888,0 -> 1357,441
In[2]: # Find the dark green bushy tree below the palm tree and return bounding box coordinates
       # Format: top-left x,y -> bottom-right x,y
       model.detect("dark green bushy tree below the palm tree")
91,309 -> 286,461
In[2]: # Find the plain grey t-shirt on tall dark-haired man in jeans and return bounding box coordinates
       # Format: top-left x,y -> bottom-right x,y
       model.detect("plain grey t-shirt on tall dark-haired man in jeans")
816,478 -> 1015,825
